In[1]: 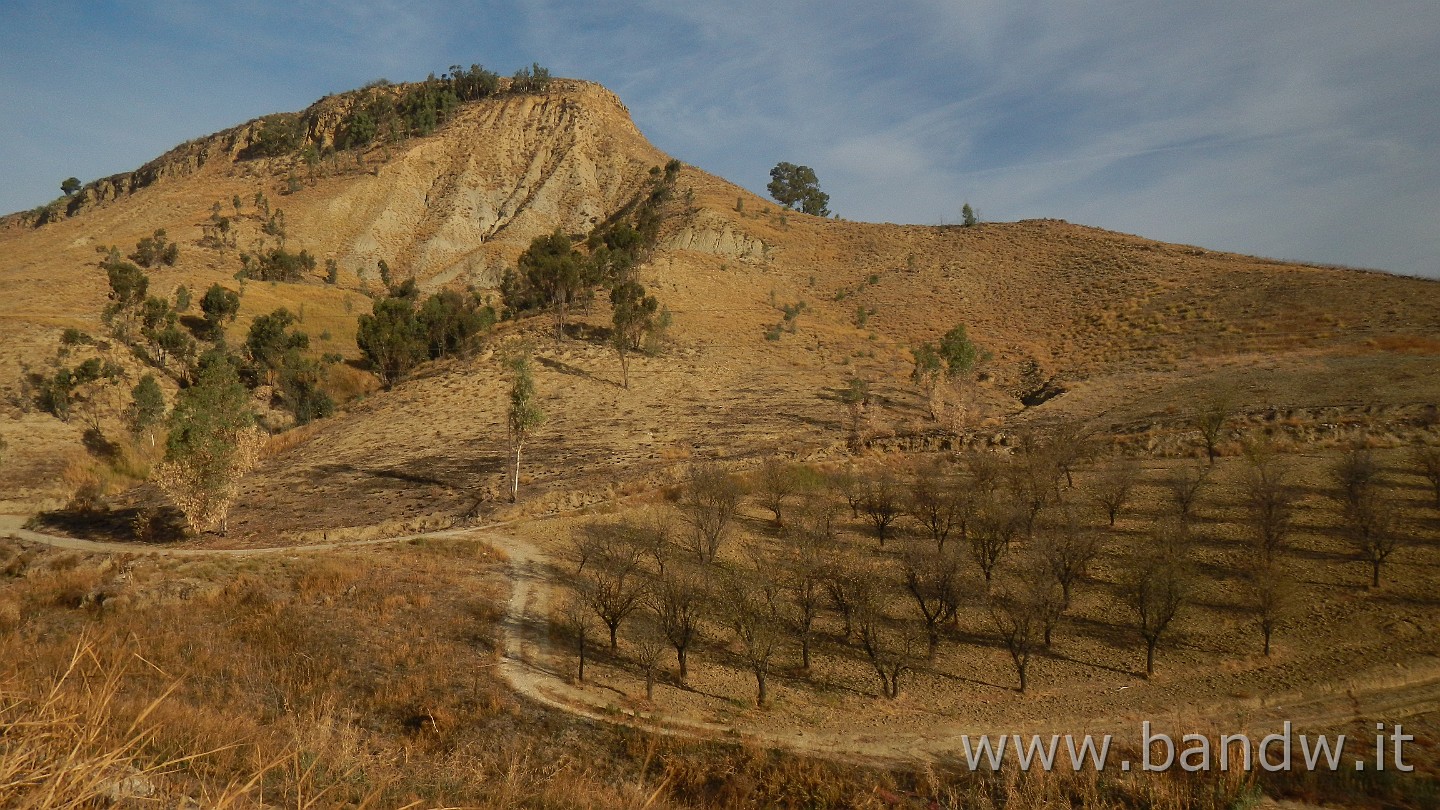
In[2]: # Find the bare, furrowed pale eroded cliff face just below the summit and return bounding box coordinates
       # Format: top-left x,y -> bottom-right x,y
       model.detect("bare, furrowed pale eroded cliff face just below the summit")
305,82 -> 667,285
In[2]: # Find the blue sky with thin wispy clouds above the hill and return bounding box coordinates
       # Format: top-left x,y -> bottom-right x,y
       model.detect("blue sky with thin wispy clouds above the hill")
0,0 -> 1440,278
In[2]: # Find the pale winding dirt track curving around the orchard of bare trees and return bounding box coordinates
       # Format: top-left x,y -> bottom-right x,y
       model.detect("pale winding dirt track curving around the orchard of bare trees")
0,515 -> 1440,765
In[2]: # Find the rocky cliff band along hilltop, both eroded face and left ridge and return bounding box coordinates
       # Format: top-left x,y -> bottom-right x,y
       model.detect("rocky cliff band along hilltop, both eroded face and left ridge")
9,81 -> 667,285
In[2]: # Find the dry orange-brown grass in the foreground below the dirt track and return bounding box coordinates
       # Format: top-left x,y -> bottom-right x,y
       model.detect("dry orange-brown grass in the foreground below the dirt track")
0,478 -> 1431,807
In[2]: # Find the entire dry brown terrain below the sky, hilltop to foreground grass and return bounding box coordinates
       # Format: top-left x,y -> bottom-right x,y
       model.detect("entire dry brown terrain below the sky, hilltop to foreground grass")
0,72 -> 1440,807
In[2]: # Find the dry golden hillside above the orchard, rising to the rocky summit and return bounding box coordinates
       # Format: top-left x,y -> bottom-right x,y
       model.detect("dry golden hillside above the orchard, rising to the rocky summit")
0,81 -> 1440,543
